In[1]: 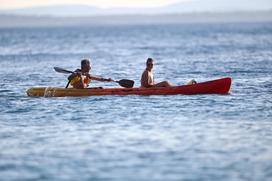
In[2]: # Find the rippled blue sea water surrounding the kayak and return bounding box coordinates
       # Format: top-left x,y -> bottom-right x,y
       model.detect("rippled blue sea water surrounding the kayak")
0,23 -> 272,181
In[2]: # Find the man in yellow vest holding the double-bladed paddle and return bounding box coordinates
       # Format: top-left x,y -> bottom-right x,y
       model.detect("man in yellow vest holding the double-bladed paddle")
66,59 -> 113,89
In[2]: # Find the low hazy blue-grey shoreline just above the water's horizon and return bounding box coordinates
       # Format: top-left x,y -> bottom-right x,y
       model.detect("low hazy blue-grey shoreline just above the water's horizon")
0,10 -> 272,28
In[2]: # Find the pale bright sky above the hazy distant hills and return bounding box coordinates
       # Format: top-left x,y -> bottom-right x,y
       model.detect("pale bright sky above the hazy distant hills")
0,0 -> 185,10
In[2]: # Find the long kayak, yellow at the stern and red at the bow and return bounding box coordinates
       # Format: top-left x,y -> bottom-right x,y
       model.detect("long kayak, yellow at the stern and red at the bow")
27,77 -> 231,97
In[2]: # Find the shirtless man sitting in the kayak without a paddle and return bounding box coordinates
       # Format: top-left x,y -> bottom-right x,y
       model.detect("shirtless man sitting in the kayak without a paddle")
141,58 -> 175,88
